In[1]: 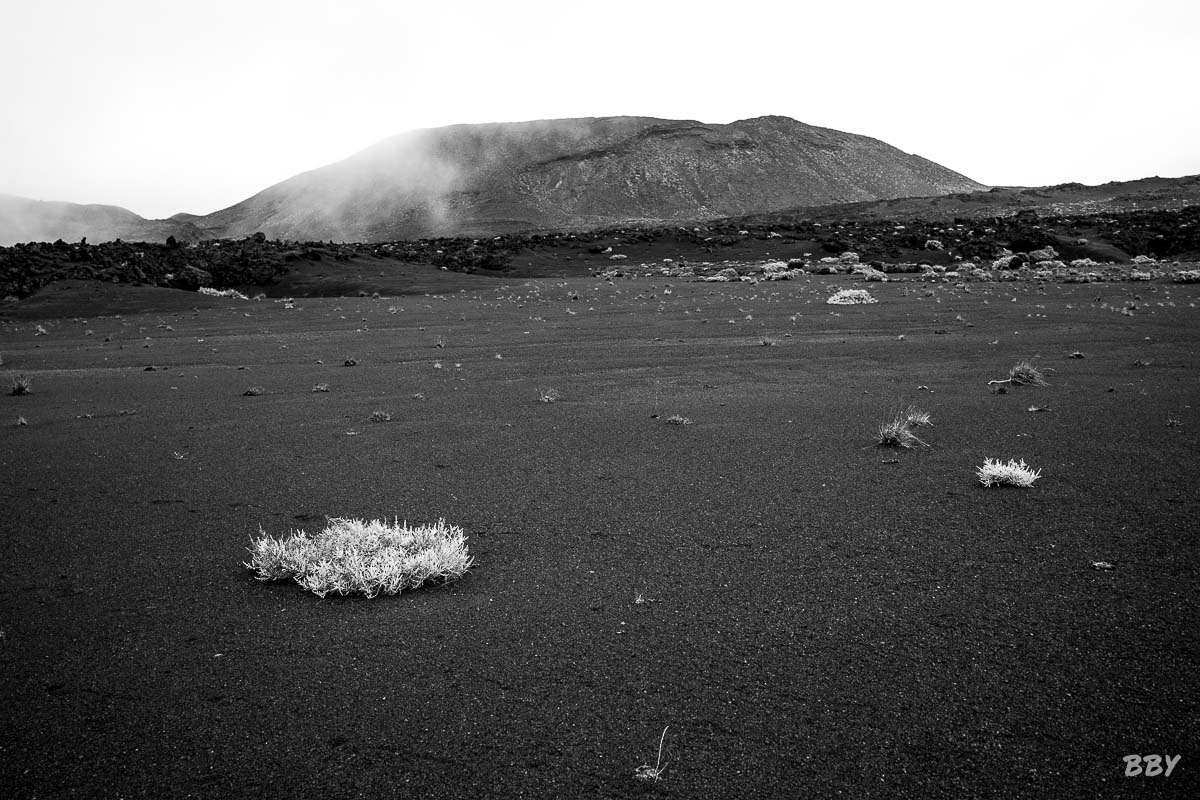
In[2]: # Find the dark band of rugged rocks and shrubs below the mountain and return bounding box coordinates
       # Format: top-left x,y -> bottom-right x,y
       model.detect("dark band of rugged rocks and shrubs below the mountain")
0,206 -> 1200,297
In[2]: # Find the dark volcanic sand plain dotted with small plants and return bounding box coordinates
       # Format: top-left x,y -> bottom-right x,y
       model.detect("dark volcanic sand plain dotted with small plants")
0,277 -> 1200,799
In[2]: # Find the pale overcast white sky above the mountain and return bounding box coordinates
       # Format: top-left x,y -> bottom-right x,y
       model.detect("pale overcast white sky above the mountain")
0,0 -> 1200,218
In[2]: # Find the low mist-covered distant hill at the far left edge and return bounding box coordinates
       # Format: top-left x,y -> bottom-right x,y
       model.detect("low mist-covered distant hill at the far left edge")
0,194 -> 202,246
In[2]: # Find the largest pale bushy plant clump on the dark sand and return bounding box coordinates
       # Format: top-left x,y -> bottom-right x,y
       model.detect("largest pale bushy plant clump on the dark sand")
246,518 -> 473,597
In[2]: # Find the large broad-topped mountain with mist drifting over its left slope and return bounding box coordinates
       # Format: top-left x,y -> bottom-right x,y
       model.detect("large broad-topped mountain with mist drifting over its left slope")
194,116 -> 984,241
